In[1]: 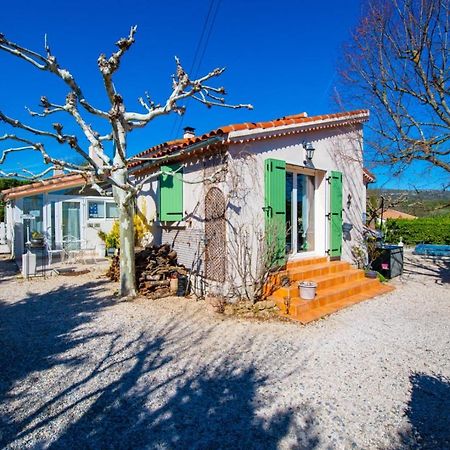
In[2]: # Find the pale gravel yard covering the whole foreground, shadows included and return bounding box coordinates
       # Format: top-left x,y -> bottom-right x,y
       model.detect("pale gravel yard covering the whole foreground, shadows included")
0,251 -> 450,449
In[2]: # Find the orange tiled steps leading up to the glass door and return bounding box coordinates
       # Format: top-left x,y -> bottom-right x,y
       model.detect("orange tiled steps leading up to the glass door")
269,257 -> 394,324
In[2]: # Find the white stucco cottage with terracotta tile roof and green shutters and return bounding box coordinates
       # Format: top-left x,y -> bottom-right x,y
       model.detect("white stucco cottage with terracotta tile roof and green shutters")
132,111 -> 390,320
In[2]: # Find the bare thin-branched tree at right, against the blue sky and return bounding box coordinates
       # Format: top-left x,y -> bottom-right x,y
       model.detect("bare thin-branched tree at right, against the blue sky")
337,0 -> 450,174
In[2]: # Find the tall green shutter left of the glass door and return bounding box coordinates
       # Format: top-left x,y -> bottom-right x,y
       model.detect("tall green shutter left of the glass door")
264,159 -> 286,264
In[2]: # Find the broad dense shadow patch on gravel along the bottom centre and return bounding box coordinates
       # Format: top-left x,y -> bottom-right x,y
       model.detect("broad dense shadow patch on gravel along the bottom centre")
50,363 -> 319,450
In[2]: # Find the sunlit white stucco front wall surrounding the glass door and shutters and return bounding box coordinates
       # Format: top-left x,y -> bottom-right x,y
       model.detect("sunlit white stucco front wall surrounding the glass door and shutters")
230,127 -> 365,262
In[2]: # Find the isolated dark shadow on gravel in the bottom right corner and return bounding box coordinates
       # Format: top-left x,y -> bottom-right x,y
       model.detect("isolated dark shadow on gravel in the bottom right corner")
401,373 -> 450,449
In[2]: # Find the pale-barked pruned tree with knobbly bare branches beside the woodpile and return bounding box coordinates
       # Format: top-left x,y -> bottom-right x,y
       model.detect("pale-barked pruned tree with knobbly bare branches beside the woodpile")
0,26 -> 252,297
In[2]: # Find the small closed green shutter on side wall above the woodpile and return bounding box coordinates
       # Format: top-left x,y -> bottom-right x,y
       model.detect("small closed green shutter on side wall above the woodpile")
159,164 -> 183,222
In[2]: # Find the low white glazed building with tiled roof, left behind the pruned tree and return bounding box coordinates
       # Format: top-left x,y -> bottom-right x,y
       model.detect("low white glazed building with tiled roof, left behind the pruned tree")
1,174 -> 119,262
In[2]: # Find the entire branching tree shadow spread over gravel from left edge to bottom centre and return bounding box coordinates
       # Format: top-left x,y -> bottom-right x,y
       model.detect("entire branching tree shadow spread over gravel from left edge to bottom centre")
0,282 -> 319,450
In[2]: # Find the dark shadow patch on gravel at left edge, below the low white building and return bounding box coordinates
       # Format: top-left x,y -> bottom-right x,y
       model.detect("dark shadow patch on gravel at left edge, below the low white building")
0,280 -> 112,448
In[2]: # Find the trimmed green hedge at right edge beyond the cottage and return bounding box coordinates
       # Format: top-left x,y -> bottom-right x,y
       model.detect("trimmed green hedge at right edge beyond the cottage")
385,215 -> 450,245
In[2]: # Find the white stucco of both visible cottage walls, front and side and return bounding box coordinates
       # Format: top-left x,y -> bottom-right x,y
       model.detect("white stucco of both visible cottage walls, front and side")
138,126 -> 365,294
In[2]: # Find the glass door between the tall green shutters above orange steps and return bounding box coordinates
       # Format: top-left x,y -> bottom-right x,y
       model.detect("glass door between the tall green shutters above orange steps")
286,172 -> 314,253
